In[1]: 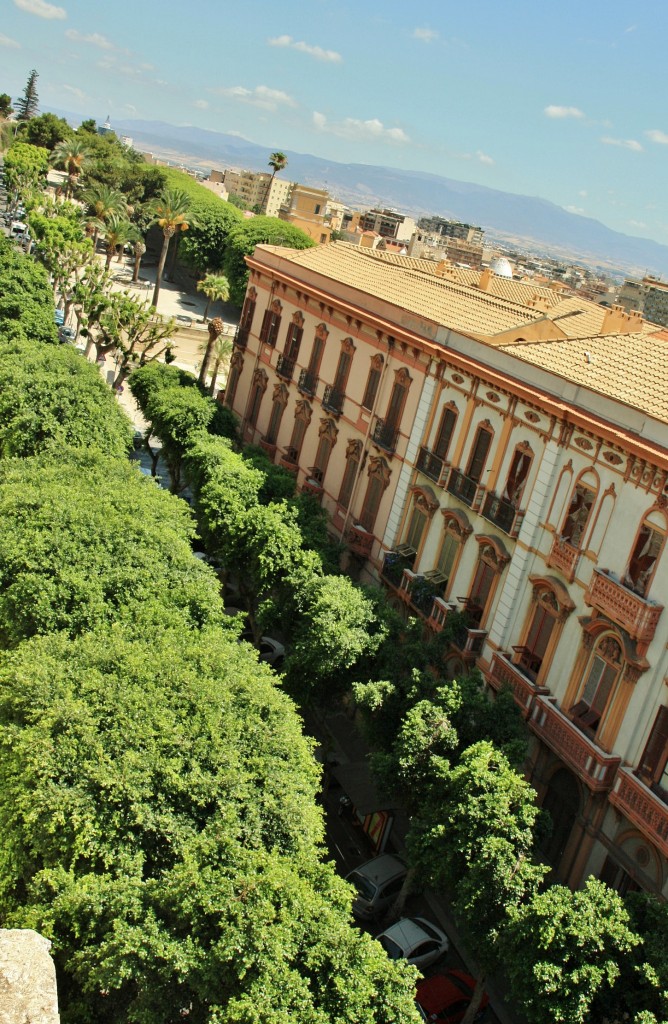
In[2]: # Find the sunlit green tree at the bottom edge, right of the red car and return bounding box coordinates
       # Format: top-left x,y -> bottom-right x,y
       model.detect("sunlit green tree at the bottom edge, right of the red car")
502,879 -> 639,1024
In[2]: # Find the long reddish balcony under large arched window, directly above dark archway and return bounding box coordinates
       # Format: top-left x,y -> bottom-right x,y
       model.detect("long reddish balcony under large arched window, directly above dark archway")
529,695 -> 621,793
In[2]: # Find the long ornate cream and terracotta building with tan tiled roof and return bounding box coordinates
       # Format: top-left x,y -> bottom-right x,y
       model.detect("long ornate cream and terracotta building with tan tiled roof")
226,243 -> 668,896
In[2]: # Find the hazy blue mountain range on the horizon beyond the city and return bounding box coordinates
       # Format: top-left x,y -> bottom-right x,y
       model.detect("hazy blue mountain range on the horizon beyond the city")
53,111 -> 668,276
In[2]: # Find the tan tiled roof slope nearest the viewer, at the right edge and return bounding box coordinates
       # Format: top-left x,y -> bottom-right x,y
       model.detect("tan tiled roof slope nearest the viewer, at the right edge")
499,330 -> 668,423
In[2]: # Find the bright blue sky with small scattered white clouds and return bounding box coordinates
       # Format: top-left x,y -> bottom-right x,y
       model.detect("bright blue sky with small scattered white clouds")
5,0 -> 668,244
